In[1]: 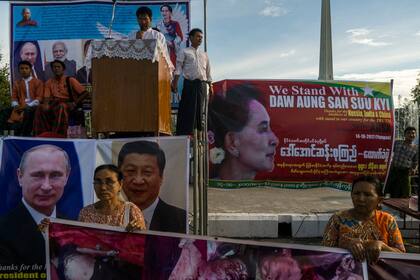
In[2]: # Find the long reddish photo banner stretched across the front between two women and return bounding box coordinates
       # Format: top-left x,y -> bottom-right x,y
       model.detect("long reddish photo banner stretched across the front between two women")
47,220 -> 366,280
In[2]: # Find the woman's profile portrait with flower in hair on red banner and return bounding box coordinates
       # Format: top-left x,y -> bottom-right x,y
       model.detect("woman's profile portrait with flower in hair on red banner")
208,85 -> 279,180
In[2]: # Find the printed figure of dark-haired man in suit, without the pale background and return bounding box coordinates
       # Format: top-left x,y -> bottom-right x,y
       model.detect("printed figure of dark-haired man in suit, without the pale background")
118,141 -> 187,233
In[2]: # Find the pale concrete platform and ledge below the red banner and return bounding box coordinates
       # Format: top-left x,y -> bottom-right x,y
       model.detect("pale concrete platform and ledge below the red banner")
190,187 -> 352,238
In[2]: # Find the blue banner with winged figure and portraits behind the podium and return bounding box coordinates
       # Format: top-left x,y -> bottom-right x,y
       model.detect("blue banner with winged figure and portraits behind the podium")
10,0 -> 190,107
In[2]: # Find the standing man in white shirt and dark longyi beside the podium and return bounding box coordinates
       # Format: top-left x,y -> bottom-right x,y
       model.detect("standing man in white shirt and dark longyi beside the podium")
171,28 -> 213,135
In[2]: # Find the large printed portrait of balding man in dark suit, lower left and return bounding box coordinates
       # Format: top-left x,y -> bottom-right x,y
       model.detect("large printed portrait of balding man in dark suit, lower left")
0,145 -> 70,273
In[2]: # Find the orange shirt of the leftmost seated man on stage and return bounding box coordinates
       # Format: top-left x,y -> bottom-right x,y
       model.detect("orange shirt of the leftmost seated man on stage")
12,77 -> 44,106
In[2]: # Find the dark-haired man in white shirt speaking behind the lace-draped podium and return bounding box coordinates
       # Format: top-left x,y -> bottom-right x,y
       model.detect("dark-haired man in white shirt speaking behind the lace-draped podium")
128,7 -> 175,73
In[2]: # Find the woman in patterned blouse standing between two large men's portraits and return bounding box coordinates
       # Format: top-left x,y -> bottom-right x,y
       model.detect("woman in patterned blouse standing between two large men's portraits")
79,164 -> 146,231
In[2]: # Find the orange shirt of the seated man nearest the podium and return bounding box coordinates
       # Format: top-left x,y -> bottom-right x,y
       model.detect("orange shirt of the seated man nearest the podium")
44,76 -> 85,100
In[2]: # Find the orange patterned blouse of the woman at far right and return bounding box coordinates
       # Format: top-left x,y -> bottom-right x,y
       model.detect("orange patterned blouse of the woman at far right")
322,210 -> 405,252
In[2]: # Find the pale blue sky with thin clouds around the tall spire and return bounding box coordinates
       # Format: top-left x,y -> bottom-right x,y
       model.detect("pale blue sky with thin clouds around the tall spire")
0,0 -> 420,107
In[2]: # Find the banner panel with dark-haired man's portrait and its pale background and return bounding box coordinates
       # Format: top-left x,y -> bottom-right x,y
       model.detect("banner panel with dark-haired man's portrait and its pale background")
96,136 -> 189,233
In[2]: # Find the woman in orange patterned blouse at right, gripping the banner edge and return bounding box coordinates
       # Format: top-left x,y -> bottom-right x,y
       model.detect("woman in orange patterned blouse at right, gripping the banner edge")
322,176 -> 405,263
